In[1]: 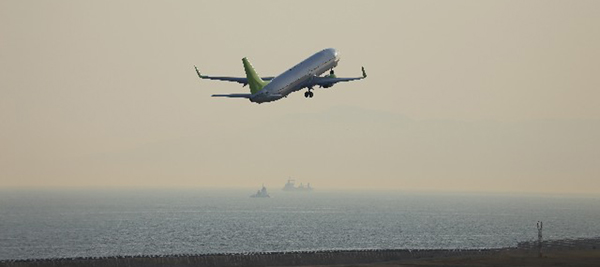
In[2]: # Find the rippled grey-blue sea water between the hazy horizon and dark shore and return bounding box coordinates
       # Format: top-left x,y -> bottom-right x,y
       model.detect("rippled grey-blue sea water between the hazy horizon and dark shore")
0,189 -> 600,259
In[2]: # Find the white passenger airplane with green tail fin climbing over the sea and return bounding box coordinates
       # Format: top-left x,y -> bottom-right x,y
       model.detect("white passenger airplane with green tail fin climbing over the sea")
194,48 -> 367,104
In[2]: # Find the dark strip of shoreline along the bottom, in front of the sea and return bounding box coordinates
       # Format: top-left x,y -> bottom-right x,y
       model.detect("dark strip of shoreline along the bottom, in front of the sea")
0,237 -> 600,267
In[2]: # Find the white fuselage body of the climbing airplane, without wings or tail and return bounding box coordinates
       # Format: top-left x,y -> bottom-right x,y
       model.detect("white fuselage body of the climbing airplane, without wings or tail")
250,48 -> 340,103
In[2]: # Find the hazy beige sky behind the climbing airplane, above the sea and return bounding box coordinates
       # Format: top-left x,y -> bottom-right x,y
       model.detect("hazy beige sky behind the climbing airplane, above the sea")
0,0 -> 600,194
